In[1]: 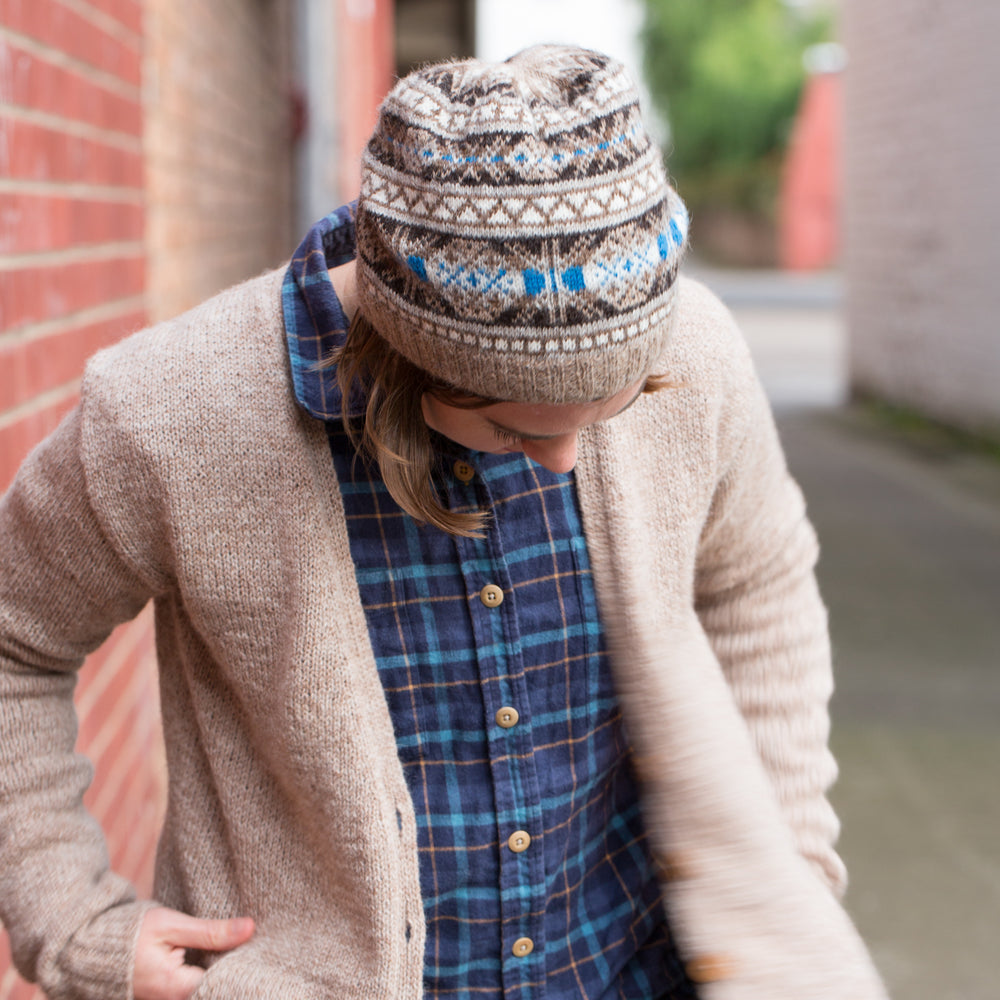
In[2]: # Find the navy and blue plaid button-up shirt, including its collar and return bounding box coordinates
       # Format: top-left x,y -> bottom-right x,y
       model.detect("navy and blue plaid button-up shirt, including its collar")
284,209 -> 696,1000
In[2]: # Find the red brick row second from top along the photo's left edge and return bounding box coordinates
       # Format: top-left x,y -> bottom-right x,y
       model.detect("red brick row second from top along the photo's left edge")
0,38 -> 142,136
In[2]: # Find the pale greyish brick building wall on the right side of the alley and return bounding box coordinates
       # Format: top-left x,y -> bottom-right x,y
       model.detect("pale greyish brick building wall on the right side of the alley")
843,0 -> 1000,436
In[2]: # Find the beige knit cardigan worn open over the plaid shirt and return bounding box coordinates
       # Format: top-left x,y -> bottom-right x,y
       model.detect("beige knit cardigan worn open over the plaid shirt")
0,272 -> 884,1000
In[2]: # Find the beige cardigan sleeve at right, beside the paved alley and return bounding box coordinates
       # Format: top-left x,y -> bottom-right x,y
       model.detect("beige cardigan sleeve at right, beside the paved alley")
695,320 -> 846,896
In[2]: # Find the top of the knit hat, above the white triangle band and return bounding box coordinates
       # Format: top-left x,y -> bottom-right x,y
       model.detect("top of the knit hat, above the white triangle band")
367,46 -> 652,191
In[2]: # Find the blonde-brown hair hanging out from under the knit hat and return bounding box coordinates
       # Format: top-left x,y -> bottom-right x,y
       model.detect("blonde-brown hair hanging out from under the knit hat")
330,312 -> 668,538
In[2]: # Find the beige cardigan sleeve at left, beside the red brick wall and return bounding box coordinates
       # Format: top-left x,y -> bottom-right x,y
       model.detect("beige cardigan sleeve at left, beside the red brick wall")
0,408 -> 162,1000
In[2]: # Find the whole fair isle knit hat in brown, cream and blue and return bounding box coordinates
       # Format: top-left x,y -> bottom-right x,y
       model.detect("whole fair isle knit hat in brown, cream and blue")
357,45 -> 687,403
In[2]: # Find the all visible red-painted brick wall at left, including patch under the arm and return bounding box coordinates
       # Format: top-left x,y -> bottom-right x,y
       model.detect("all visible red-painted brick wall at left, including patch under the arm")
0,0 -> 163,1000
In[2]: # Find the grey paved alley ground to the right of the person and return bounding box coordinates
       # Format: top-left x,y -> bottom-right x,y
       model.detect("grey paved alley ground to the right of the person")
696,269 -> 1000,1000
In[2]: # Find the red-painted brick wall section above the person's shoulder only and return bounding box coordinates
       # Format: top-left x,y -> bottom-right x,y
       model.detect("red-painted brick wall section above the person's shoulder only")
0,0 -> 145,486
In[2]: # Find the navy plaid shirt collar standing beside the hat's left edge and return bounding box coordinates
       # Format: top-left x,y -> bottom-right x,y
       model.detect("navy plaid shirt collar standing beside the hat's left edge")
281,202 -> 364,420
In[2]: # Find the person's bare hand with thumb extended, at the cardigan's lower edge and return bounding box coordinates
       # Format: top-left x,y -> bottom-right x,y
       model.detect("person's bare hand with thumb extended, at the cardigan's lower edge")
132,906 -> 254,1000
